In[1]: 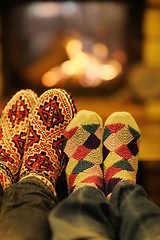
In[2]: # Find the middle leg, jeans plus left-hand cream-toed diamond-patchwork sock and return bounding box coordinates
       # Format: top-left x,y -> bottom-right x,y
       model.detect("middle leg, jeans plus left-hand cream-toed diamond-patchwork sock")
49,110 -> 117,240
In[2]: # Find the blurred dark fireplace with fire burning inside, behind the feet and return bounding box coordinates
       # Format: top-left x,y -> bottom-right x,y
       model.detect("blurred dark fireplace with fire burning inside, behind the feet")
2,1 -> 143,95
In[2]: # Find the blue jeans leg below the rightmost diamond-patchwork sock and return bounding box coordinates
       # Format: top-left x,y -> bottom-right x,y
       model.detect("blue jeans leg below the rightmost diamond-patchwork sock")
110,181 -> 160,240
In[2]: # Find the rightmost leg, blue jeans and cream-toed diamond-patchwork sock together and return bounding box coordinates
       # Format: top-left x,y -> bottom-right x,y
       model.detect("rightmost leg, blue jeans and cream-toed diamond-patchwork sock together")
103,112 -> 160,240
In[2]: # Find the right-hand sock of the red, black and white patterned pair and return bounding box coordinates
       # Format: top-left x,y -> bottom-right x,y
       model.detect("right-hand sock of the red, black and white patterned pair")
20,89 -> 76,194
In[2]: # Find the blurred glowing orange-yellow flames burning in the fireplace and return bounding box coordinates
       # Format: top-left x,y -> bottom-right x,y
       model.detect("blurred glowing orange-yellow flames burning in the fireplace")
42,38 -> 122,87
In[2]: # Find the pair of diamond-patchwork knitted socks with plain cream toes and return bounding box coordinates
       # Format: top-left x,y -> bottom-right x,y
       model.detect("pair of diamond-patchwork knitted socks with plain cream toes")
63,110 -> 140,198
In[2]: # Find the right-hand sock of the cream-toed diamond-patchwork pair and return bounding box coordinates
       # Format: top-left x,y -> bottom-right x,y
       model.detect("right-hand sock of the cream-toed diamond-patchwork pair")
103,112 -> 140,198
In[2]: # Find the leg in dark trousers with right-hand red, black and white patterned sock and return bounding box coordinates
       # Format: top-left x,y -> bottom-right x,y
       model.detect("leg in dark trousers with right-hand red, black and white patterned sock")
1,89 -> 76,240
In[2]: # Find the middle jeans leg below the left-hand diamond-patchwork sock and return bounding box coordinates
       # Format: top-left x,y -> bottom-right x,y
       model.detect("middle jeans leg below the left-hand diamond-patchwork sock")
49,186 -> 119,240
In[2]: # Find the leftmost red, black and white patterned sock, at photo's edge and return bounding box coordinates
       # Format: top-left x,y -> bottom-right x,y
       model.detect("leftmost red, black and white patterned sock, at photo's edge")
0,89 -> 38,190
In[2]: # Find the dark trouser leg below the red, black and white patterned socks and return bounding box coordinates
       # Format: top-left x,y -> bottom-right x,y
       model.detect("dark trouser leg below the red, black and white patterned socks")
0,178 -> 56,240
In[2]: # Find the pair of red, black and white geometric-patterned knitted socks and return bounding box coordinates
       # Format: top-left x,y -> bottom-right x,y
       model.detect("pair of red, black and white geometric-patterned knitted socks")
0,89 -> 76,193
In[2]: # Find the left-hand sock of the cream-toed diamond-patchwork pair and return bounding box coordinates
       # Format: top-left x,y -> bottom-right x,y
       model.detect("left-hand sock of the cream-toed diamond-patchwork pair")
63,110 -> 103,193
